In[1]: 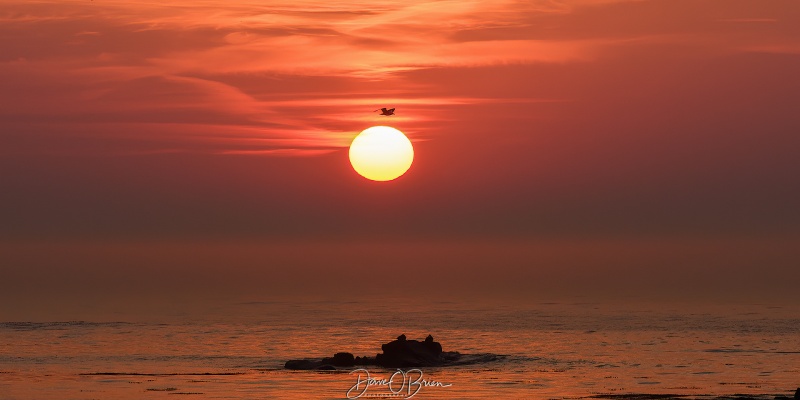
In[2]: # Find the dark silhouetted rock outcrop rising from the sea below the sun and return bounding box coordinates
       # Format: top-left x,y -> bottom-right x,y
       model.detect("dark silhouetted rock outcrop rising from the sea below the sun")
284,335 -> 502,370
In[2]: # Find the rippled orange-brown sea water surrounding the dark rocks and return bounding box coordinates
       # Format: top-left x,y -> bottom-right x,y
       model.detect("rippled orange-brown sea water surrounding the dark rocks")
0,300 -> 800,400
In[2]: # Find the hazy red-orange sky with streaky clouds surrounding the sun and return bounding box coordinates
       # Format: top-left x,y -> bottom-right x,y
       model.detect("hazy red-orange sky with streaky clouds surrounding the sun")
0,0 -> 800,319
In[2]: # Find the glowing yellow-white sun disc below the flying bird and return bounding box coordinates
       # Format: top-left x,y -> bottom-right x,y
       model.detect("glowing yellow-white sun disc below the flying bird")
350,126 -> 414,181
